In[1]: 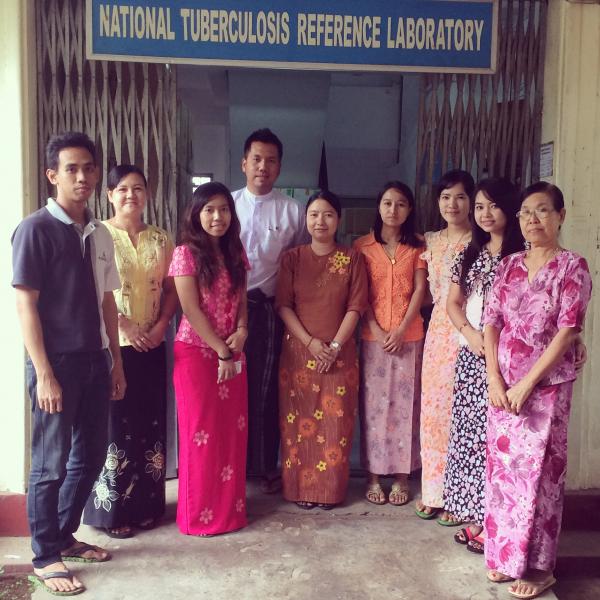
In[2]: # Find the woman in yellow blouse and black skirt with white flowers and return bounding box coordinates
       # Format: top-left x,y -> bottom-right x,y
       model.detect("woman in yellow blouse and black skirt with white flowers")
83,165 -> 177,538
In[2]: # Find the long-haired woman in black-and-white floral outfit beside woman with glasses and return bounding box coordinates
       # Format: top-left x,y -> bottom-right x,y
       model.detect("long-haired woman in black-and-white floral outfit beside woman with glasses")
444,179 -> 523,553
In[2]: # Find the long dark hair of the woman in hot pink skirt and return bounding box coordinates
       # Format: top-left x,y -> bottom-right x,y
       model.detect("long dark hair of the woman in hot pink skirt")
181,181 -> 246,293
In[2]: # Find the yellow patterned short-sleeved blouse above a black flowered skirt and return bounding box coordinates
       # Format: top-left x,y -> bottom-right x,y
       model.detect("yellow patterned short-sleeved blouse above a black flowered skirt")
104,221 -> 173,346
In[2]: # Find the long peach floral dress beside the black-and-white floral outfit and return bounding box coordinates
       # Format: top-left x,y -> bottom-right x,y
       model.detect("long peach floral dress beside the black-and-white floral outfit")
421,230 -> 469,508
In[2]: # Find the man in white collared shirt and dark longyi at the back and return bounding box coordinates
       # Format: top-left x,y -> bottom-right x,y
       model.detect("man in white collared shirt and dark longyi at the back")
233,129 -> 307,493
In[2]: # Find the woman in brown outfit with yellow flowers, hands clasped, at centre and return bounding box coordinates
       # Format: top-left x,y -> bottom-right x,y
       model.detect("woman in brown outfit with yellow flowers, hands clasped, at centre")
275,191 -> 367,509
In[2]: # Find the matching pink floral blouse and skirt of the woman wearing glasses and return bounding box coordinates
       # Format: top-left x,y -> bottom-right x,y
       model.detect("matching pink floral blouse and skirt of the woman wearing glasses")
484,250 -> 592,578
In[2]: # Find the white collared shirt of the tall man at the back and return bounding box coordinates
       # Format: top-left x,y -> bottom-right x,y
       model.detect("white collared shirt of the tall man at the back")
232,187 -> 308,296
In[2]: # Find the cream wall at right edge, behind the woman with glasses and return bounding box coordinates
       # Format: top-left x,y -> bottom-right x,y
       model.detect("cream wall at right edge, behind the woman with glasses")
542,0 -> 600,489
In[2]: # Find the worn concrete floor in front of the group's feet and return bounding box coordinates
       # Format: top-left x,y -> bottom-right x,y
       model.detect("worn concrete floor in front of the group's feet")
0,478 -> 584,600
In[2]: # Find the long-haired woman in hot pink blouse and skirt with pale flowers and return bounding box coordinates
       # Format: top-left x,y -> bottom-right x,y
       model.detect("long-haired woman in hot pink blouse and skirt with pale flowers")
169,182 -> 248,535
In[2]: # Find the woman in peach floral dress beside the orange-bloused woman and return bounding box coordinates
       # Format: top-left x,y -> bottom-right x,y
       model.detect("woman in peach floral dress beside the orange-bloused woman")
415,170 -> 475,525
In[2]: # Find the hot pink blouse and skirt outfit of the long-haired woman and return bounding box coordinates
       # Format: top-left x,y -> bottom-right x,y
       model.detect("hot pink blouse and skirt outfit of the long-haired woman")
169,246 -> 248,535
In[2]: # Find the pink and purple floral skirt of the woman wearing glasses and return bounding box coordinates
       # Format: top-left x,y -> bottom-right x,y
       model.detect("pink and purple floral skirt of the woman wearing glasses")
485,381 -> 573,579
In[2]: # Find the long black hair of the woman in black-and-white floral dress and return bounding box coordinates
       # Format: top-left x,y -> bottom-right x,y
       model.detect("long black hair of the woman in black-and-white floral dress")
460,177 -> 524,295
